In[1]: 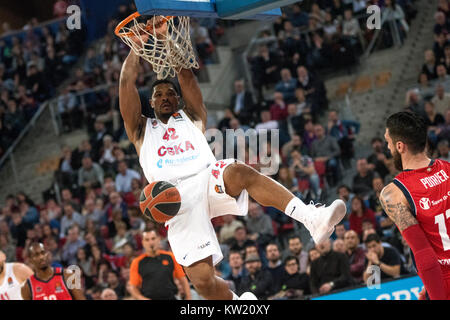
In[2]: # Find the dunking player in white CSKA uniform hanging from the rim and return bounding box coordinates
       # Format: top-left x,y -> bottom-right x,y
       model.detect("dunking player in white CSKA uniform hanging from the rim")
119,21 -> 346,300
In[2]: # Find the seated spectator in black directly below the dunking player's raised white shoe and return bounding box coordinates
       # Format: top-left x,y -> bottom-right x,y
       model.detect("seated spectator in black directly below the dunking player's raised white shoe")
310,239 -> 351,294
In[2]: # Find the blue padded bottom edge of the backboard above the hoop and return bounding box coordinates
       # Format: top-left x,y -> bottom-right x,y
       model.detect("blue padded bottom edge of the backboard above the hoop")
135,0 -> 299,20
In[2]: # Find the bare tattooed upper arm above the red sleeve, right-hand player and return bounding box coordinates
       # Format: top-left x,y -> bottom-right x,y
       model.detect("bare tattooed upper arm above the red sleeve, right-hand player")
380,183 -> 417,231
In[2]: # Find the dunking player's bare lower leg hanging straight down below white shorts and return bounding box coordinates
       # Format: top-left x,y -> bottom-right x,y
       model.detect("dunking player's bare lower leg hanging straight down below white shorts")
184,256 -> 237,300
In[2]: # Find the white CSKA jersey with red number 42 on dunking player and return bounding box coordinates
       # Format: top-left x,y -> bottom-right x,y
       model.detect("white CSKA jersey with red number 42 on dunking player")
139,110 -> 216,184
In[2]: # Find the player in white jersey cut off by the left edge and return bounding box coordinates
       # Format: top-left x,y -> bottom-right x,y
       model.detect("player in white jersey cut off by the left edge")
0,250 -> 33,300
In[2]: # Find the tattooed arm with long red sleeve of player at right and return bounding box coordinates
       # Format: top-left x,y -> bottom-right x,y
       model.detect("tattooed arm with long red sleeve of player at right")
380,183 -> 447,300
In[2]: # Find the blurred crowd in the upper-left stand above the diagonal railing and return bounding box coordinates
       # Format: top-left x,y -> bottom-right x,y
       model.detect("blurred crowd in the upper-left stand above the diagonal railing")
0,0 -> 84,157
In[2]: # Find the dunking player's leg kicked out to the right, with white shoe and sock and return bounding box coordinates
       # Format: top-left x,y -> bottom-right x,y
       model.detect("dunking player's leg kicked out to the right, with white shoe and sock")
223,162 -> 346,243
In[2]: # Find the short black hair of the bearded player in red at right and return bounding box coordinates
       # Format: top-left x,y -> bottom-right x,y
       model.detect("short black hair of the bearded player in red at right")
386,111 -> 427,154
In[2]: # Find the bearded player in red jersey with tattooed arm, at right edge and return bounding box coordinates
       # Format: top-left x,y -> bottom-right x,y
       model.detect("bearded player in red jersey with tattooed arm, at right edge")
380,112 -> 450,300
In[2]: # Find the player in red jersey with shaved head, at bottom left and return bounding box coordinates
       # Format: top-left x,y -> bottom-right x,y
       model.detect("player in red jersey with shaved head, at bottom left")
22,243 -> 86,300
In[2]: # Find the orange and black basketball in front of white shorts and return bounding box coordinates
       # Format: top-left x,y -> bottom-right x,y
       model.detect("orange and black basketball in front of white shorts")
139,181 -> 181,223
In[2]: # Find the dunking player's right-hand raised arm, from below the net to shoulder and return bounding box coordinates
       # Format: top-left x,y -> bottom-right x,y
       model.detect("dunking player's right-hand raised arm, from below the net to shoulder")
178,69 -> 207,132
